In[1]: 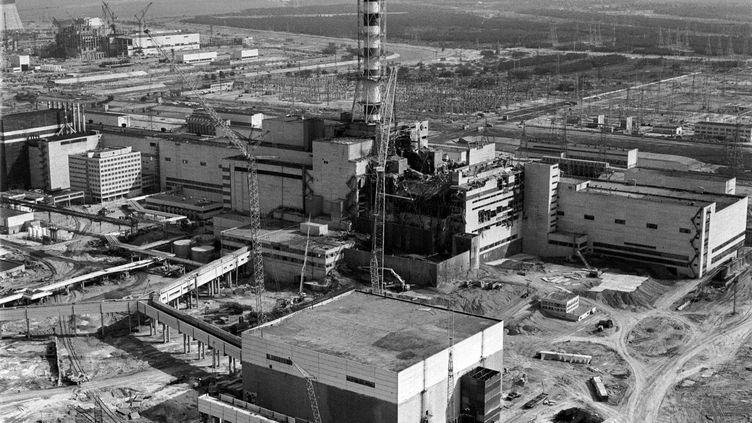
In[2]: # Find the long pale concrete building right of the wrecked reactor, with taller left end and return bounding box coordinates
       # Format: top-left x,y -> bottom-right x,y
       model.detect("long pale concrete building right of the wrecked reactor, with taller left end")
523,163 -> 747,277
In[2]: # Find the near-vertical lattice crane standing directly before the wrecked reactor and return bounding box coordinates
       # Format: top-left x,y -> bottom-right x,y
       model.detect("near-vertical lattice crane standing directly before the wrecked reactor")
370,68 -> 397,294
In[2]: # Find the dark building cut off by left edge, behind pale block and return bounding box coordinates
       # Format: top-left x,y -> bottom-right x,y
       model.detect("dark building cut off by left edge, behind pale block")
0,109 -> 66,191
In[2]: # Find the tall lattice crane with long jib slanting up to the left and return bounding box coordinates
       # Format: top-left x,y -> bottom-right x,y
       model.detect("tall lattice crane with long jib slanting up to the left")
144,29 -> 264,325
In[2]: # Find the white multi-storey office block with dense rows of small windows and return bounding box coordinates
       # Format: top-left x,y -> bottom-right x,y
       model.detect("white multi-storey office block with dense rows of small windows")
68,147 -> 142,203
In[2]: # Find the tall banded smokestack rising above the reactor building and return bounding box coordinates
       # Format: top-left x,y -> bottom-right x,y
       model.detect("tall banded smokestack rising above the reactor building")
356,0 -> 386,123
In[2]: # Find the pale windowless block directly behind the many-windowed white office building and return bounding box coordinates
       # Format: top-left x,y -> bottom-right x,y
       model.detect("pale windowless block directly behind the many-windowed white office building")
28,132 -> 101,191
